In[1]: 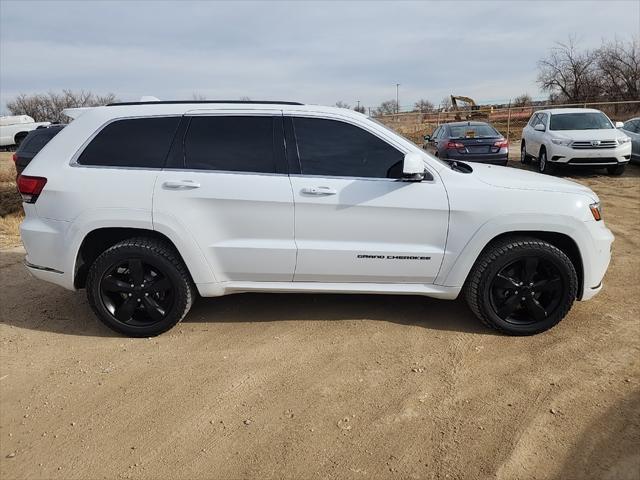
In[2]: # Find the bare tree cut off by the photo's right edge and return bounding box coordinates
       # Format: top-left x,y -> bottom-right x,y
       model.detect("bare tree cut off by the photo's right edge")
596,38 -> 640,100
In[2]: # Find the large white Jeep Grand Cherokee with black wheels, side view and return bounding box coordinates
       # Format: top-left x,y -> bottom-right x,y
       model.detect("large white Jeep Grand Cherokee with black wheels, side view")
18,102 -> 613,336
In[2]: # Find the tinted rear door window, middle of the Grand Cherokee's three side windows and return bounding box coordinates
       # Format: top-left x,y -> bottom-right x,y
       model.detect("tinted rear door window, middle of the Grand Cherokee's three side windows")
184,116 -> 276,173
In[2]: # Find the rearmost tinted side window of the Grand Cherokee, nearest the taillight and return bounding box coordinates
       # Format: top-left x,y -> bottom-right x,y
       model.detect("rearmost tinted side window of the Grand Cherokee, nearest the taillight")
78,117 -> 180,168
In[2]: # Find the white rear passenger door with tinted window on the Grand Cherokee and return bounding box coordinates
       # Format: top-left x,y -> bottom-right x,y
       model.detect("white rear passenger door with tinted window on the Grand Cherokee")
153,110 -> 296,282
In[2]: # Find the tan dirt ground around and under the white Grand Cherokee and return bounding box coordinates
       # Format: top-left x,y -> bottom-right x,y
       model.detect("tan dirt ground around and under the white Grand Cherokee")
0,151 -> 640,480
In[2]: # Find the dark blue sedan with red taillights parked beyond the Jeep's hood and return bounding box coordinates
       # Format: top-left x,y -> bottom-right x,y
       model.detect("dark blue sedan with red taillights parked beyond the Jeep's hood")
423,122 -> 509,165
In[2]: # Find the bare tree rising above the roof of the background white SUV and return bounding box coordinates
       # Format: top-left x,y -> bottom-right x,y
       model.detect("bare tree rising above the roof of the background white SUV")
538,37 -> 600,103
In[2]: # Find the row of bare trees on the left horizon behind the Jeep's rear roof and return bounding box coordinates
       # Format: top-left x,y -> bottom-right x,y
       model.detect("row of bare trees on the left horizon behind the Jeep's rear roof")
7,90 -> 117,122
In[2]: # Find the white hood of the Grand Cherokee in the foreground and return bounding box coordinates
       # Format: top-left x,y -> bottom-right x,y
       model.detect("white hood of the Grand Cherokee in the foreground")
471,163 -> 598,202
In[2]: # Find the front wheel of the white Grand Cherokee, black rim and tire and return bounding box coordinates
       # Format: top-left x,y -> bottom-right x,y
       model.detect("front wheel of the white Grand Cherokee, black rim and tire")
464,237 -> 578,335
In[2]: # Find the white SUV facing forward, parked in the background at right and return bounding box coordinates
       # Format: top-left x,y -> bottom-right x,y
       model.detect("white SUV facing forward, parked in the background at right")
520,108 -> 631,175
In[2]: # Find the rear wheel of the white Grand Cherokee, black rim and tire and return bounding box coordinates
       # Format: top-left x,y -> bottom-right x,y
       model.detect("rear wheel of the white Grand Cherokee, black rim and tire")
86,237 -> 196,337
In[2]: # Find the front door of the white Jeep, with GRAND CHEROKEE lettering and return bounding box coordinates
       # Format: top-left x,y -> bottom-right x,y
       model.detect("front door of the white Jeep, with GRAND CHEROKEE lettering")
286,116 -> 449,283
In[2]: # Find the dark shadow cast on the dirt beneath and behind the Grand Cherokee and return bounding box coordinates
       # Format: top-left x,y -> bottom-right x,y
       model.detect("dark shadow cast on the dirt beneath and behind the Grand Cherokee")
0,250 -> 495,337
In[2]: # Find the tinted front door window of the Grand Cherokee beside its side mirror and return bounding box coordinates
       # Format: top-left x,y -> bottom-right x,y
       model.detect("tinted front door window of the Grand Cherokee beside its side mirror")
293,117 -> 404,178
